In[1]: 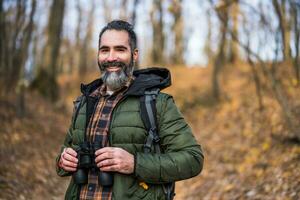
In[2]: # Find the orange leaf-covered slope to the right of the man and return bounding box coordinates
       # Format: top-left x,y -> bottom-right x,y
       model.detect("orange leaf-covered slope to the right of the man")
170,68 -> 300,200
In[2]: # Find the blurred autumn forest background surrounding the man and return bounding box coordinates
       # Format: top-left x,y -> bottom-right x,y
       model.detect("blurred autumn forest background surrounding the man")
0,0 -> 300,200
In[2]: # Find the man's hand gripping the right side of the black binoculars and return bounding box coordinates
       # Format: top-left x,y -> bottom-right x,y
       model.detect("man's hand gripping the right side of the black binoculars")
95,147 -> 134,174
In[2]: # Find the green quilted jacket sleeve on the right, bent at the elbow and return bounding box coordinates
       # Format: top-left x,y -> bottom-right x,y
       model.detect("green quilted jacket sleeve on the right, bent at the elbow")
135,94 -> 204,184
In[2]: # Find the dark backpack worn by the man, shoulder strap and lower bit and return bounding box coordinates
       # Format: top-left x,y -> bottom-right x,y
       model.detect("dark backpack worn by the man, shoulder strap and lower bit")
140,88 -> 175,200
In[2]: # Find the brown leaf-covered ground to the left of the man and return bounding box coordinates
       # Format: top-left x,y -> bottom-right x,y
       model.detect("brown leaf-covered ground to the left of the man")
0,95 -> 69,200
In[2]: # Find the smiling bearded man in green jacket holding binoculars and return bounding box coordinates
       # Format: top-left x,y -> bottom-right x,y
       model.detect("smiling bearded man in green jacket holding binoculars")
57,20 -> 203,200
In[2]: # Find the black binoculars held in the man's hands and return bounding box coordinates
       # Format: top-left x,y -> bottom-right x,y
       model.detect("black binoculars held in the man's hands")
73,142 -> 113,187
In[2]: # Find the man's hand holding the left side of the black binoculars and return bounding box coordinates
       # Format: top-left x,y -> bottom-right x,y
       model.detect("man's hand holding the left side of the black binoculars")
58,148 -> 78,172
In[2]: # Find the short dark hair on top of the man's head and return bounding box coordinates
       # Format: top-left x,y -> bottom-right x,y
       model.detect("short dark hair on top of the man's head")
99,20 -> 137,52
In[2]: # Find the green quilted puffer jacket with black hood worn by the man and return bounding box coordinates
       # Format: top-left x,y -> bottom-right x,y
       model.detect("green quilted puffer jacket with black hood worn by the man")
56,68 -> 203,200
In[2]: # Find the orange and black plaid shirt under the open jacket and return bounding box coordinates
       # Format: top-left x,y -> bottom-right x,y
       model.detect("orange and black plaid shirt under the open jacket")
80,79 -> 133,200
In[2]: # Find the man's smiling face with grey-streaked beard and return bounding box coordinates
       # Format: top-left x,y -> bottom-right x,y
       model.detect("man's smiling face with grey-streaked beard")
98,30 -> 138,90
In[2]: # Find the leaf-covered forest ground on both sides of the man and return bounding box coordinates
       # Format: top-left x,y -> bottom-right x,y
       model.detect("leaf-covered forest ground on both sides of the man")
0,65 -> 300,200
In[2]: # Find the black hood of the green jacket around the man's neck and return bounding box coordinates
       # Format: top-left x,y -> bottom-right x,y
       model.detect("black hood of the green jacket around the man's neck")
81,67 -> 171,96
